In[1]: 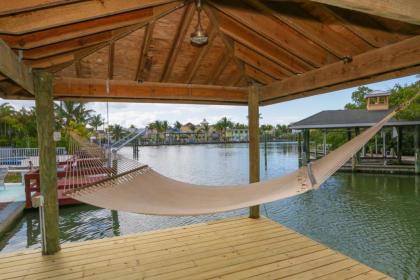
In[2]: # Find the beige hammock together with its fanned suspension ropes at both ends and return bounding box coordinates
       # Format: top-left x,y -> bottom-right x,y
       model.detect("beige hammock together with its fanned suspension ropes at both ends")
63,94 -> 417,216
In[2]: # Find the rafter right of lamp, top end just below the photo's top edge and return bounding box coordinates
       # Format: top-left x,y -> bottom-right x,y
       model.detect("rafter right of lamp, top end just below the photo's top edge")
213,9 -> 314,74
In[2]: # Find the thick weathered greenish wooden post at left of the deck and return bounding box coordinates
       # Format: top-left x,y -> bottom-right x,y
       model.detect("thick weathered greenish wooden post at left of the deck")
34,71 -> 60,255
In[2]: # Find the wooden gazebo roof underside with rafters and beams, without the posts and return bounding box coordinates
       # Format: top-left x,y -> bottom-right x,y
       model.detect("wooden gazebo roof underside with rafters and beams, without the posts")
0,0 -> 420,105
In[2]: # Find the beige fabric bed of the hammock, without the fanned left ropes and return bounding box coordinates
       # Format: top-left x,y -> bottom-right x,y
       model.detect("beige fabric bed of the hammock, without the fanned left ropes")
61,98 -> 410,216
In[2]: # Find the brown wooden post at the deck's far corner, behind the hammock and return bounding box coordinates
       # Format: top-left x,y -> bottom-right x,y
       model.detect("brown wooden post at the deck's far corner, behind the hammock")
248,86 -> 260,219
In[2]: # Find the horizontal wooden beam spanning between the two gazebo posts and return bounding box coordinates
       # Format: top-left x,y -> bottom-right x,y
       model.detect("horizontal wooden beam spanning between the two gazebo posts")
54,78 -> 248,104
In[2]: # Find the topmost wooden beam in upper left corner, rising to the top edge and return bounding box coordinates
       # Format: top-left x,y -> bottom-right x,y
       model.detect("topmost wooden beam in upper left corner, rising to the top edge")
0,0 -> 179,34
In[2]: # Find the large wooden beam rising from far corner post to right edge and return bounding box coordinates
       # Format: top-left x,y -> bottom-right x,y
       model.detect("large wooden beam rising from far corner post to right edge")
262,36 -> 420,104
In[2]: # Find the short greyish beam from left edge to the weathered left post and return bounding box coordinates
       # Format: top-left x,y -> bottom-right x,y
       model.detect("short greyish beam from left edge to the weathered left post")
0,40 -> 34,94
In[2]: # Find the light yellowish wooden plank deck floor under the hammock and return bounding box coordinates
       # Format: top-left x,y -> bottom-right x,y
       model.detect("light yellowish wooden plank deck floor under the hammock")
0,218 -> 390,280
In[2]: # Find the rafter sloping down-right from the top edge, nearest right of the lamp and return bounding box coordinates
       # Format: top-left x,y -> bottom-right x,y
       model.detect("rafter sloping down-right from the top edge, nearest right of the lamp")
210,1 -> 338,67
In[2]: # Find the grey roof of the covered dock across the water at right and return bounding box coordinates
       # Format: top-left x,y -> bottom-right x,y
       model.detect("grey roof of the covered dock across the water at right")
289,110 -> 420,129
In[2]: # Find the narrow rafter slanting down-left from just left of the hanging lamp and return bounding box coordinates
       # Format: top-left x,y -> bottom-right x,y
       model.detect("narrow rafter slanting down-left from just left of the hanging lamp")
160,3 -> 195,82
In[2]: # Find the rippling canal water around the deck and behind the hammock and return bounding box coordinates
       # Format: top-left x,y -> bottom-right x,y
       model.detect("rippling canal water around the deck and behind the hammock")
0,143 -> 420,279
